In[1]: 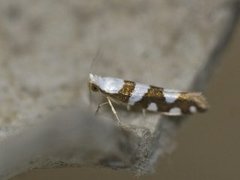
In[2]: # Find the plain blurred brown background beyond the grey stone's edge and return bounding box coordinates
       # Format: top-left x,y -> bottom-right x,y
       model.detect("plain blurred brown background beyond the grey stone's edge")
12,17 -> 240,180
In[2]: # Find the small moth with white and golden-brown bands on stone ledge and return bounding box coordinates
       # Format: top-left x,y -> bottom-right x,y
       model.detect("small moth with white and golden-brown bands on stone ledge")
89,73 -> 208,121
